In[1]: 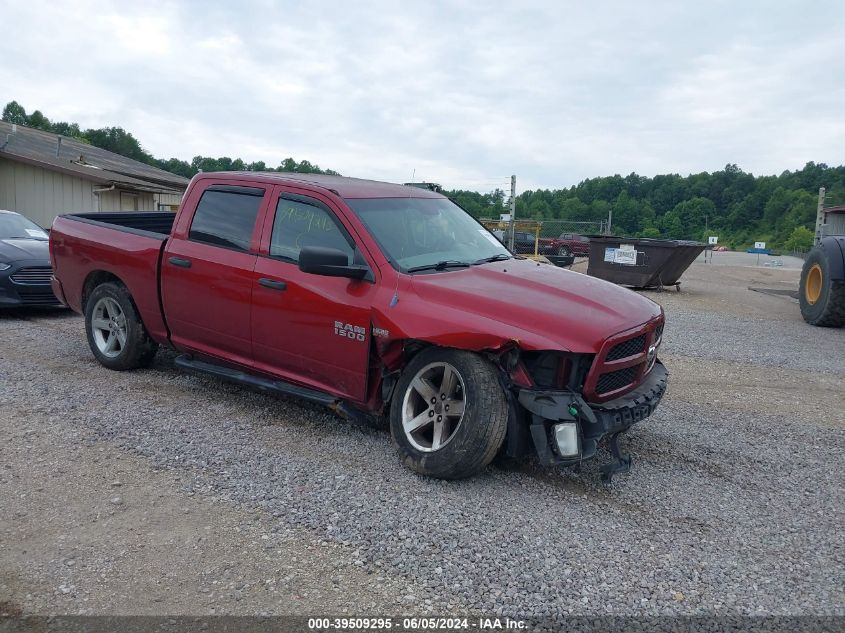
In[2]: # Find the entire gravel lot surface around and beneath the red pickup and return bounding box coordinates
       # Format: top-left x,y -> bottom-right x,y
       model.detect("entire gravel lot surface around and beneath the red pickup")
0,264 -> 845,617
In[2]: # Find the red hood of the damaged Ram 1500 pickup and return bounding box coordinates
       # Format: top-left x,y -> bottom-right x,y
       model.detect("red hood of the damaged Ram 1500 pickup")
413,260 -> 661,353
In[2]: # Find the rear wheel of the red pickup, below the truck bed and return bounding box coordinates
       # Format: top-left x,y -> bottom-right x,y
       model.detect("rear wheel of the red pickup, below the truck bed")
85,282 -> 158,371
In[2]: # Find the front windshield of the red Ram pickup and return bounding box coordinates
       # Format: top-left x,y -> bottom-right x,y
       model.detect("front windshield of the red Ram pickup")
346,198 -> 510,272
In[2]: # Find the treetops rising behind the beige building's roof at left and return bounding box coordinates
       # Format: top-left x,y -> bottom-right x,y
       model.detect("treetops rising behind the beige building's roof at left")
2,101 -> 340,178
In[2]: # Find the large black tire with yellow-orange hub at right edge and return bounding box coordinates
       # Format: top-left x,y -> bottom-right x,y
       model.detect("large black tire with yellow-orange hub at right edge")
798,247 -> 845,327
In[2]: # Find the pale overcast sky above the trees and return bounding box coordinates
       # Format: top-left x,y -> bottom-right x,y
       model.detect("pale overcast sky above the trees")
0,0 -> 845,191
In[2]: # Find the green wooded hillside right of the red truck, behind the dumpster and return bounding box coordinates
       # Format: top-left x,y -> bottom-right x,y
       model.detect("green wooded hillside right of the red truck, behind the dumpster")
449,162 -> 845,250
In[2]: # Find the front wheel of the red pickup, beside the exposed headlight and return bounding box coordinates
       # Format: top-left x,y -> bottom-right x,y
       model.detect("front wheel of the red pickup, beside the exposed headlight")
390,348 -> 508,479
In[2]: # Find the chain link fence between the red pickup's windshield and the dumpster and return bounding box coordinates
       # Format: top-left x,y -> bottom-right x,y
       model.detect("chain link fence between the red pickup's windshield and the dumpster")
481,218 -> 607,258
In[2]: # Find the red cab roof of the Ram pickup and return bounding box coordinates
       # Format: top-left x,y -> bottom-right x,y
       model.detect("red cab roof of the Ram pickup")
201,171 -> 443,199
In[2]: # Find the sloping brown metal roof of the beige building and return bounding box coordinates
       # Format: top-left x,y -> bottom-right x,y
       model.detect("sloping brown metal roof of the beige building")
0,121 -> 188,193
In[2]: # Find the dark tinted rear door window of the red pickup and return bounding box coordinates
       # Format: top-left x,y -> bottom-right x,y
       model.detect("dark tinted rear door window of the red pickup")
188,185 -> 264,251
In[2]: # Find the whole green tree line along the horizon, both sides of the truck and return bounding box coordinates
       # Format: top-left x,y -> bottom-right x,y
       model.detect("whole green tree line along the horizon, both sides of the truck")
2,101 -> 845,250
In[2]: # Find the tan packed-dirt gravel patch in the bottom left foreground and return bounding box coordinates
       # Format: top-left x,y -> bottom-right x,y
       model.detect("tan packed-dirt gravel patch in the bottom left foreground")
0,414 -> 420,616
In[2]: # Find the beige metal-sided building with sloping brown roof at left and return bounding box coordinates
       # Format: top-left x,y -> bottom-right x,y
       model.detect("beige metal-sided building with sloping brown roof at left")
0,121 -> 188,228
